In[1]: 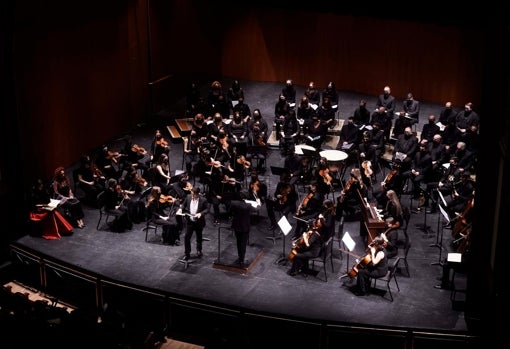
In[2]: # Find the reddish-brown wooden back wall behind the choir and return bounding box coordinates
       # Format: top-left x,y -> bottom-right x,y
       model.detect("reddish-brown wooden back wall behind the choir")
222,10 -> 483,106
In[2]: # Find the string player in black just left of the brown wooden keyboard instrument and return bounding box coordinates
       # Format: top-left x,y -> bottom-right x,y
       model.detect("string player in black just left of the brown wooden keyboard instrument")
335,167 -> 368,220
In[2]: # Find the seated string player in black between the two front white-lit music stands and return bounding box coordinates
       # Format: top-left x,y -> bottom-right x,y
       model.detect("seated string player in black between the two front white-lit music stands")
287,218 -> 324,276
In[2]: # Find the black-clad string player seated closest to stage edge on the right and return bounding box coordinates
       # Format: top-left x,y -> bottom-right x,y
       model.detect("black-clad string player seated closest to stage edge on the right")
353,236 -> 388,296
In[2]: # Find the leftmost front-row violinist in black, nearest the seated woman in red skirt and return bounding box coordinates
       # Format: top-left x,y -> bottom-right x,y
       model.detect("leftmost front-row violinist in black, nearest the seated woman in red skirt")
104,178 -> 133,233
